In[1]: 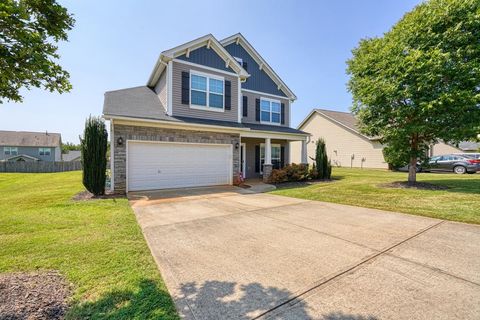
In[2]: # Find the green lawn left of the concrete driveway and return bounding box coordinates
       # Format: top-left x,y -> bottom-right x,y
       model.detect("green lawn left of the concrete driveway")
0,171 -> 178,319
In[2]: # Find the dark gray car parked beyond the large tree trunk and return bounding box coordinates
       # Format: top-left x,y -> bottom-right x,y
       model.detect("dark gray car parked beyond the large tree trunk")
422,154 -> 480,174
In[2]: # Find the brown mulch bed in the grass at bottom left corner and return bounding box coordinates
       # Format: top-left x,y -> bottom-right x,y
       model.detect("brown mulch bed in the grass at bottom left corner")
0,271 -> 71,320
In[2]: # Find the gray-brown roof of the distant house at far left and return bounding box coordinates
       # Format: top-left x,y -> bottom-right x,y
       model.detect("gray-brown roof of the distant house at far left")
0,131 -> 62,147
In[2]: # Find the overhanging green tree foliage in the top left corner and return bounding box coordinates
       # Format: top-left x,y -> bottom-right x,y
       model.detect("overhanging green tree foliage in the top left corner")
0,0 -> 75,103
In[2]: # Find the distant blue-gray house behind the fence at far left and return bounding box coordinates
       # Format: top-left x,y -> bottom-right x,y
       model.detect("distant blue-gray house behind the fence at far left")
0,131 -> 62,161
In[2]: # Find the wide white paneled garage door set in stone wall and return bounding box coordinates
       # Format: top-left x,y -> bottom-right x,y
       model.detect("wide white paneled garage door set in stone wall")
127,141 -> 232,191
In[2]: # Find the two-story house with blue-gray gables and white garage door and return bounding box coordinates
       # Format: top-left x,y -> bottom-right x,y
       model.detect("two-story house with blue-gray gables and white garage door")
103,34 -> 308,192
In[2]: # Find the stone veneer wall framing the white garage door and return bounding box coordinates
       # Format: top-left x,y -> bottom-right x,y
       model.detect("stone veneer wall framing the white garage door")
111,124 -> 240,193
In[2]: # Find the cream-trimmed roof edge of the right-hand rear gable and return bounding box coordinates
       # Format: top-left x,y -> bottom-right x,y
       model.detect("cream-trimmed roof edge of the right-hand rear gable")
220,33 -> 297,100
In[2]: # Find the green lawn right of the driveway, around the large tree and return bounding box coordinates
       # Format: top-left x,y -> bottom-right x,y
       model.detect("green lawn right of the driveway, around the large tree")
272,168 -> 480,224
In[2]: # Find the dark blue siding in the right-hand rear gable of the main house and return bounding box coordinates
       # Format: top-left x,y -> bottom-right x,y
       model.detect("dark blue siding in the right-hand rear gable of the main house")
225,43 -> 286,97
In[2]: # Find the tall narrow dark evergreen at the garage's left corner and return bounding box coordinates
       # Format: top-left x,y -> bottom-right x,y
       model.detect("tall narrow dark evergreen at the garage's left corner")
80,116 -> 108,196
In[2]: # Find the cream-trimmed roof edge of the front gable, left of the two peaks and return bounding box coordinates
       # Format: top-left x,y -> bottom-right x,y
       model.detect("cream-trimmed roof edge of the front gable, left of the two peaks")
147,34 -> 250,87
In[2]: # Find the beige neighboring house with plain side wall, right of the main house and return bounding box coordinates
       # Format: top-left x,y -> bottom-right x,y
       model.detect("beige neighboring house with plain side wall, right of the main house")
291,109 -> 463,169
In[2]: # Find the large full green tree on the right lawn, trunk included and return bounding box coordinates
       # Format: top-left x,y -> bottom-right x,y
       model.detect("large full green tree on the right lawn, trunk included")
347,0 -> 480,184
